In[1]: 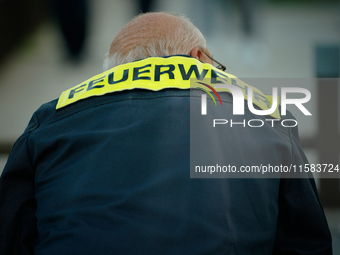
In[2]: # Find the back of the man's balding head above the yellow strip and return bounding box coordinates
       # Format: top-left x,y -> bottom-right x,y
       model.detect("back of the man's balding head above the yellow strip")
104,12 -> 206,70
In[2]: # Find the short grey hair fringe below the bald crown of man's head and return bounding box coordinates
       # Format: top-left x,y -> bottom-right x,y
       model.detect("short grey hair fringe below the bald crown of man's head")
103,15 -> 206,71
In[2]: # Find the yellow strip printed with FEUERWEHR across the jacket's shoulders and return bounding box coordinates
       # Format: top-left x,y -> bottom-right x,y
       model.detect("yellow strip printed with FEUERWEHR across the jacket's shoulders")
56,56 -> 280,119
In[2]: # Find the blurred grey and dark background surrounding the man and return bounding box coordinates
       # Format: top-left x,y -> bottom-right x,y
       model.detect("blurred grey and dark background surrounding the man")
0,0 -> 340,254
